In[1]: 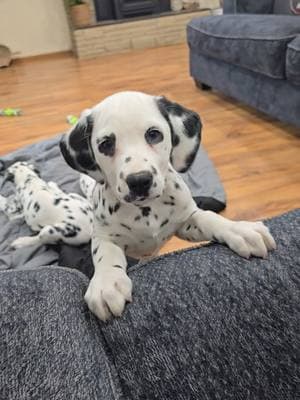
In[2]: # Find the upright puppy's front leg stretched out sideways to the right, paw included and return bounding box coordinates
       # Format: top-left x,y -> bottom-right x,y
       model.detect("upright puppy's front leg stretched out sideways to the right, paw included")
177,210 -> 276,258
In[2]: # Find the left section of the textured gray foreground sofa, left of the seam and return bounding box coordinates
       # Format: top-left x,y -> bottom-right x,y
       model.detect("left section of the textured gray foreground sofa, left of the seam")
0,267 -> 120,400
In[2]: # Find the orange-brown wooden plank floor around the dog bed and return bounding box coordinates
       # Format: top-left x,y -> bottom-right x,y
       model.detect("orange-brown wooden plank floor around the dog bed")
0,45 -> 300,251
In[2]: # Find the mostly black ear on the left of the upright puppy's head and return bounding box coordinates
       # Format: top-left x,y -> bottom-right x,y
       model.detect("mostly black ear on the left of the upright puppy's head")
60,112 -> 104,182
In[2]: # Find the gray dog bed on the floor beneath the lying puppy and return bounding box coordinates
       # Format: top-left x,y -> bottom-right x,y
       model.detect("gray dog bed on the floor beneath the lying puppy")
0,136 -> 226,276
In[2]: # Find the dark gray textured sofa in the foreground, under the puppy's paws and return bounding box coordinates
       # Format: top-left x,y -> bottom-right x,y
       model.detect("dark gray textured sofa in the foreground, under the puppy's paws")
0,210 -> 300,400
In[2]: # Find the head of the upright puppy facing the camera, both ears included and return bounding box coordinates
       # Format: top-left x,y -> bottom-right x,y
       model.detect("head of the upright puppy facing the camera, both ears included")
60,92 -> 201,204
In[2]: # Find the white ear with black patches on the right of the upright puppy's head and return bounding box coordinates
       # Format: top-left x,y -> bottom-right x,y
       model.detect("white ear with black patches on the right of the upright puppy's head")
156,97 -> 202,172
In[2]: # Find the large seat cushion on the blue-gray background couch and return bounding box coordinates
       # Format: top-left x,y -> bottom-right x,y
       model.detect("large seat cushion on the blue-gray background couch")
187,15 -> 300,79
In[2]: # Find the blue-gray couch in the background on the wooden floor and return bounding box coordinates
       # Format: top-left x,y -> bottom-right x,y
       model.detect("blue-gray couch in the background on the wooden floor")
187,0 -> 300,127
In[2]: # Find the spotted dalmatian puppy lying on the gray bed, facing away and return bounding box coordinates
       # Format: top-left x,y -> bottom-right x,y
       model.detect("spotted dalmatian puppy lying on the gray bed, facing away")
0,162 -> 93,248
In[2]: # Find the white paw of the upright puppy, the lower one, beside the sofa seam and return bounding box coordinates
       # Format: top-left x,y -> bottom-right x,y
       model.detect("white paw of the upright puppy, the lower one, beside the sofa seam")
84,265 -> 132,321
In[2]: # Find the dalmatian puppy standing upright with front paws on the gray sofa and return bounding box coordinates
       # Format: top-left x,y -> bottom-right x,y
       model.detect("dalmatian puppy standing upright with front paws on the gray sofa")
60,92 -> 275,321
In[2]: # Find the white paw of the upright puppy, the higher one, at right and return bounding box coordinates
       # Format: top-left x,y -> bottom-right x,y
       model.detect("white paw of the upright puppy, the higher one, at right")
221,221 -> 276,258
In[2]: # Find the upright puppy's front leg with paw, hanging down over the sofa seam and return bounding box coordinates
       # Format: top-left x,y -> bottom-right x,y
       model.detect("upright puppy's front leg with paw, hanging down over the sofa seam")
84,238 -> 132,321
